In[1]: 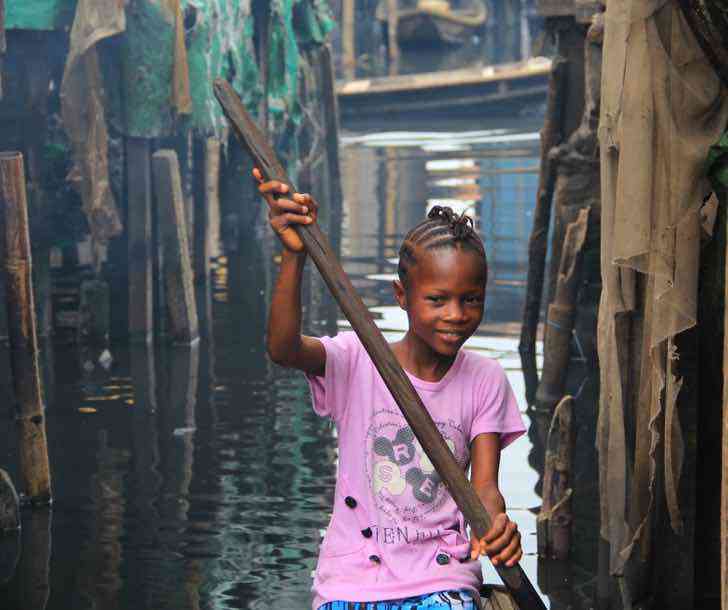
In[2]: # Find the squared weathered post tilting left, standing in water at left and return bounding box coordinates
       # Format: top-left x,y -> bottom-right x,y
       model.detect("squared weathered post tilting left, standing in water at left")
152,150 -> 199,344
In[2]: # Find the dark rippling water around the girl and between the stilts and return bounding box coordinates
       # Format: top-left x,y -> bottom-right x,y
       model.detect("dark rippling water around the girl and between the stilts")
0,119 -> 596,610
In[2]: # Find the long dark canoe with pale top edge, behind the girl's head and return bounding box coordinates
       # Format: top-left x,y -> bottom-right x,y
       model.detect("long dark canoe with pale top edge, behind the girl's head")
337,59 -> 551,120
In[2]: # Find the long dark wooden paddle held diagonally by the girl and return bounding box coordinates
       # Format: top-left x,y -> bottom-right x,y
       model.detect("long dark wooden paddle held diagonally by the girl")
214,79 -> 546,610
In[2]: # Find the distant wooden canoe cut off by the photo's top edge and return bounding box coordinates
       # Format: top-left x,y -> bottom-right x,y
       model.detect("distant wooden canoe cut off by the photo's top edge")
377,0 -> 488,47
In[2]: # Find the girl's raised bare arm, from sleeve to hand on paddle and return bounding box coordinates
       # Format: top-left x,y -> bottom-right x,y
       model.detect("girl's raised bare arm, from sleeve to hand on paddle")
253,169 -> 326,375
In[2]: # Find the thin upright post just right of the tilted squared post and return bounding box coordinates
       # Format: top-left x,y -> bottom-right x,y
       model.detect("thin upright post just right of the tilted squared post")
192,138 -> 212,337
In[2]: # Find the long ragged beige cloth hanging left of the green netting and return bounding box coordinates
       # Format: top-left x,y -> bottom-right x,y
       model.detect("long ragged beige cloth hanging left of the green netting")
61,0 -> 126,263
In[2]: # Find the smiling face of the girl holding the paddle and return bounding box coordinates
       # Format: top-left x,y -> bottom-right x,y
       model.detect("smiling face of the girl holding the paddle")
394,248 -> 486,357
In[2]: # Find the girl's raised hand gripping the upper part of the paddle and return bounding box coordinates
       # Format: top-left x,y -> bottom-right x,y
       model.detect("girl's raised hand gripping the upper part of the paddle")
253,167 -> 318,254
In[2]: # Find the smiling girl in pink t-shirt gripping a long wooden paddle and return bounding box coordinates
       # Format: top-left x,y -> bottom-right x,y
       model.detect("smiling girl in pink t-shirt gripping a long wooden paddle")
254,170 -> 524,610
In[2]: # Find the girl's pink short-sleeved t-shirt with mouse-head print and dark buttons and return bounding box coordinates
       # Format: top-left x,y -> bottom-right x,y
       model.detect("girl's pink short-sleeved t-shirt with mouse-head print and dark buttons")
308,332 -> 525,610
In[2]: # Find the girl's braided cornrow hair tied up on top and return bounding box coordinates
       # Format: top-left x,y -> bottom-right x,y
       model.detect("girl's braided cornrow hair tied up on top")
397,205 -> 488,287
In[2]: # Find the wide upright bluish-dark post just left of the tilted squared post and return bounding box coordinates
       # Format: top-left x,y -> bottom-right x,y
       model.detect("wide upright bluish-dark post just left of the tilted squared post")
126,137 -> 154,343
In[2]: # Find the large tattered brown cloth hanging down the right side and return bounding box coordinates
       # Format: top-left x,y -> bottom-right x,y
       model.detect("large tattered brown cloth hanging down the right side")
597,0 -> 728,575
